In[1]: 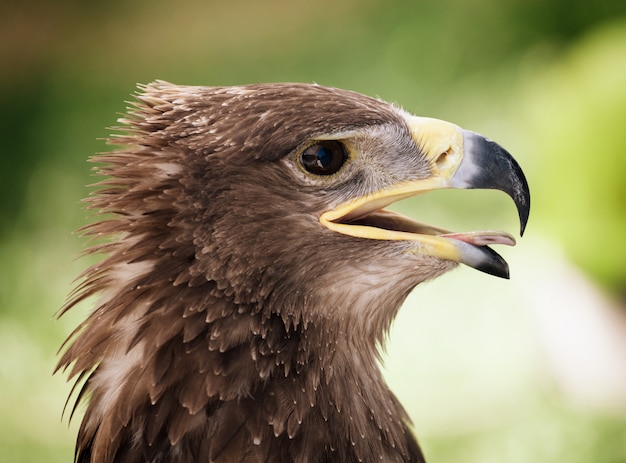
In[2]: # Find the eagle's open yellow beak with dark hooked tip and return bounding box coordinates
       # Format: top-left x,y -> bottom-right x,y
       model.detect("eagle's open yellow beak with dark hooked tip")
320,116 -> 530,278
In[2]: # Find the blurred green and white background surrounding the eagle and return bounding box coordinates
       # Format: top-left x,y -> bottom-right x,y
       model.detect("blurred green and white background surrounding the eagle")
0,0 -> 626,463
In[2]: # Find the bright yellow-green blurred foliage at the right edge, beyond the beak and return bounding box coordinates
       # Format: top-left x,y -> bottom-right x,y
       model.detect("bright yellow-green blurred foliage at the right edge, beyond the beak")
516,21 -> 626,294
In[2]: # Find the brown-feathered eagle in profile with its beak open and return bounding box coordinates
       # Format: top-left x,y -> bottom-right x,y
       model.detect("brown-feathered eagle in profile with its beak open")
57,81 -> 530,463
